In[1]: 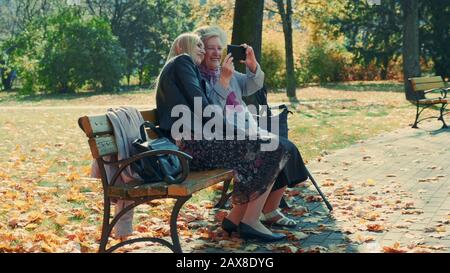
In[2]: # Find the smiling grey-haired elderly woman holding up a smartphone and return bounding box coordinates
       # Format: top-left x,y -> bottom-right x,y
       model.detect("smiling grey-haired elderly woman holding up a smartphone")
195,26 -> 308,227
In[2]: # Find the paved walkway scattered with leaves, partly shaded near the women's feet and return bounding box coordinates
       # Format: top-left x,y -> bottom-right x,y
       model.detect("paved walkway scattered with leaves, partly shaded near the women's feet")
135,121 -> 450,252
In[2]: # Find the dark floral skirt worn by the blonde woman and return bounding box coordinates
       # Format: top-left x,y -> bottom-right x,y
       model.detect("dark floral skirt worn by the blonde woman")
177,139 -> 289,204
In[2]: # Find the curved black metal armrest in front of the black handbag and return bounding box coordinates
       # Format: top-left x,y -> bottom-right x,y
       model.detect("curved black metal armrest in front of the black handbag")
109,150 -> 192,186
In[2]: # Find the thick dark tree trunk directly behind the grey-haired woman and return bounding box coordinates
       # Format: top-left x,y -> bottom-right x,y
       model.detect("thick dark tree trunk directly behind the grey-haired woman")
231,0 -> 264,73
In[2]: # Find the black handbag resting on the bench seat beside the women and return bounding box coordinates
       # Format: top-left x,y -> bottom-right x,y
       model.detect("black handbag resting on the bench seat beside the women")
132,121 -> 187,184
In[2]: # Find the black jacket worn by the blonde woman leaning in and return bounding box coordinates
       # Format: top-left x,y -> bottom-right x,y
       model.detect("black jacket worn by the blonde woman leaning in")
156,54 -> 236,138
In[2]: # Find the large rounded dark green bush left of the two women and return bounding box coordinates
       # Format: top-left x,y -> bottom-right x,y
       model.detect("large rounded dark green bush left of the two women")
38,10 -> 125,92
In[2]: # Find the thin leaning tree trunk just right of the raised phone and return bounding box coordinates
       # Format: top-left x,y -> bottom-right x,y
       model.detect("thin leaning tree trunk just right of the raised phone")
275,0 -> 297,100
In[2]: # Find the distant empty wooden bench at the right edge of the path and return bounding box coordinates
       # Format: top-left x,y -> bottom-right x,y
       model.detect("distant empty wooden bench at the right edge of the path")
409,76 -> 449,128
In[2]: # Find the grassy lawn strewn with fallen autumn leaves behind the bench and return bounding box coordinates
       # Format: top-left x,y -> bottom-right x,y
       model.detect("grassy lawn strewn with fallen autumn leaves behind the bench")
0,83 -> 415,252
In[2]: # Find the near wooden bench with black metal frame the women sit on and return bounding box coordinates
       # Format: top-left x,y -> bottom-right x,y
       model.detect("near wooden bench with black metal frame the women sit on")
78,109 -> 233,253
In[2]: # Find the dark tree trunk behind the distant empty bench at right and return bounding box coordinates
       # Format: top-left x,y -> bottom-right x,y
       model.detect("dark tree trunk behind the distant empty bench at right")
401,0 -> 423,100
